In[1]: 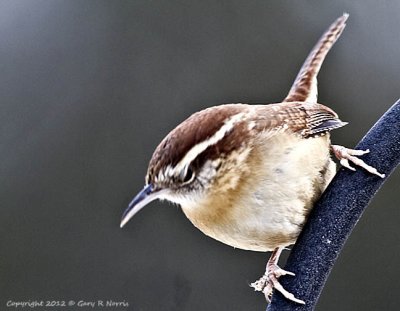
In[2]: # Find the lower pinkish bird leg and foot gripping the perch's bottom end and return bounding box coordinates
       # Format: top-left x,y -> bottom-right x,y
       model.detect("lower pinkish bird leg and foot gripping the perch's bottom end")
250,247 -> 305,304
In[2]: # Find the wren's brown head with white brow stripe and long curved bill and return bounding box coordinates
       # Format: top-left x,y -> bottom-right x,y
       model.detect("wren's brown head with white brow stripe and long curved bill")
121,104 -> 255,227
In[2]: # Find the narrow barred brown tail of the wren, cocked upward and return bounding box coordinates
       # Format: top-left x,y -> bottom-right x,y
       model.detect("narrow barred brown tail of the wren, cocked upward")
283,13 -> 349,103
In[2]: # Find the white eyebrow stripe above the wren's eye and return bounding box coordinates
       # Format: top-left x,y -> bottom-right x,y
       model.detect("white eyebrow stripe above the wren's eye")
173,112 -> 245,174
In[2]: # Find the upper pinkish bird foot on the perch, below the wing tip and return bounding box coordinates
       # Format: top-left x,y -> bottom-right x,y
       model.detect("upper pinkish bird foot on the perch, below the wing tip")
331,145 -> 385,178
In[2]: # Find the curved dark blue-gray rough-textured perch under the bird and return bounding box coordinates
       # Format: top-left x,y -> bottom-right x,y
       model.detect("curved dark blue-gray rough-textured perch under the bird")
267,100 -> 400,311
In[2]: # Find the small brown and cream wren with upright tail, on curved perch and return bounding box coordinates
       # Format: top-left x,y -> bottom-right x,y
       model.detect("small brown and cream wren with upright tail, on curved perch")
121,14 -> 384,303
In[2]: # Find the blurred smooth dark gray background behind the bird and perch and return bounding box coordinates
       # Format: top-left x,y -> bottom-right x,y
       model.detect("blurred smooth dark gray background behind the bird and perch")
0,0 -> 400,311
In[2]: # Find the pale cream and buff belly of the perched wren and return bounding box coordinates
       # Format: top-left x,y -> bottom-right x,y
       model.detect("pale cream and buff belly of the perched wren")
182,137 -> 335,251
